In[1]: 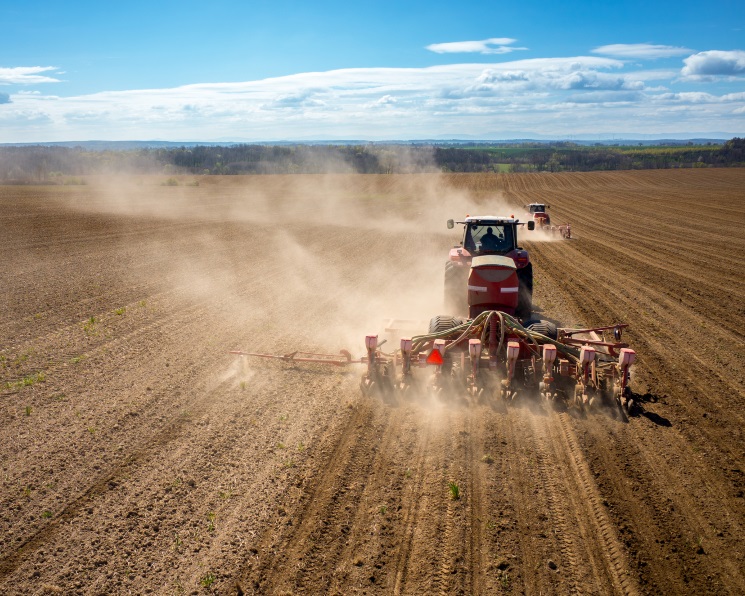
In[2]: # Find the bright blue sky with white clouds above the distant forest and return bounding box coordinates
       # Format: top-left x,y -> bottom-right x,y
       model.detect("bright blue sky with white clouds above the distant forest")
0,0 -> 745,142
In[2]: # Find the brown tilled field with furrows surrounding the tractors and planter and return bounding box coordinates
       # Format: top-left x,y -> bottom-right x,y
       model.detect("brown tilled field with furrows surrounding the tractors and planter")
0,169 -> 745,594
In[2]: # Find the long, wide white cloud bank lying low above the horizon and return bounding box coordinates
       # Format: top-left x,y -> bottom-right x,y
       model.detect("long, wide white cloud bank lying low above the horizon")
0,56 -> 745,142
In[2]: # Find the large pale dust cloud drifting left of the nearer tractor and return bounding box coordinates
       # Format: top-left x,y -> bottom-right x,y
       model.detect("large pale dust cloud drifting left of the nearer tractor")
58,173 -> 533,356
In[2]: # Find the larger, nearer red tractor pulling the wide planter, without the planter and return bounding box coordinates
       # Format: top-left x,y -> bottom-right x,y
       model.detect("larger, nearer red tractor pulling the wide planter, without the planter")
445,215 -> 535,320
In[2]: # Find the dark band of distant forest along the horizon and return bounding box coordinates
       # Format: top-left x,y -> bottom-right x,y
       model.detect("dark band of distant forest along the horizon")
0,138 -> 745,184
